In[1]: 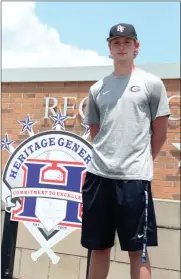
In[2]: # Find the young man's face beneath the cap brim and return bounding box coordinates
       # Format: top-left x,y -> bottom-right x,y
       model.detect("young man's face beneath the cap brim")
109,37 -> 139,61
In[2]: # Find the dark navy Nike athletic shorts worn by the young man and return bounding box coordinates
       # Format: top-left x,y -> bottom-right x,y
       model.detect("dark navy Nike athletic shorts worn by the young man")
81,172 -> 158,256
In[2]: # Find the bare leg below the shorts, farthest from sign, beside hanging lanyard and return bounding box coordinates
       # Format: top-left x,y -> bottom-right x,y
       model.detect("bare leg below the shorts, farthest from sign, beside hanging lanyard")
129,251 -> 151,279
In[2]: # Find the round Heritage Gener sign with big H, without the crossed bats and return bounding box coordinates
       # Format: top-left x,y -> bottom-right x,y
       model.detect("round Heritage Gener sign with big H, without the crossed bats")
3,131 -> 91,231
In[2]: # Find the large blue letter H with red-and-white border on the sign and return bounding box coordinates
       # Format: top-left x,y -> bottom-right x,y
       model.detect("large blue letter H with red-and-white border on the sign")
12,159 -> 86,230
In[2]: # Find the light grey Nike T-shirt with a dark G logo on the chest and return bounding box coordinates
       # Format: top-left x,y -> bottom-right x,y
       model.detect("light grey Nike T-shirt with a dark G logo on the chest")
84,68 -> 170,181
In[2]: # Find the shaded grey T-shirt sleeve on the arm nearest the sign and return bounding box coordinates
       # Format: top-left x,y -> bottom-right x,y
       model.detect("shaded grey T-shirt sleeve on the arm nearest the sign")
84,89 -> 100,124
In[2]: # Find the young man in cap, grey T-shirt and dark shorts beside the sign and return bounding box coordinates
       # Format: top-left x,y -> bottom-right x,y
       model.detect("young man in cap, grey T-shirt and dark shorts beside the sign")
81,23 -> 170,279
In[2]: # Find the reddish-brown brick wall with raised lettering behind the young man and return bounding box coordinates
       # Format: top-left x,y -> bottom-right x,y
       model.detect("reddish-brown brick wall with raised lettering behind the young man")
2,80 -> 180,200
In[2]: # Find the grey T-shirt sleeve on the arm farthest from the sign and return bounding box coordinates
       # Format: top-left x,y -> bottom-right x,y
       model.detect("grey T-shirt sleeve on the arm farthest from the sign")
150,79 -> 170,121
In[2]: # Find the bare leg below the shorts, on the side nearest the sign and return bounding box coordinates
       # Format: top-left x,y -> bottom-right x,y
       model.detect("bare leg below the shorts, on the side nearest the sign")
88,249 -> 111,279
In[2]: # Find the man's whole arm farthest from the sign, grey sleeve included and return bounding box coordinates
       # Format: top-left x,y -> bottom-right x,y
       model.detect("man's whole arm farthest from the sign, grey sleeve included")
150,79 -> 170,160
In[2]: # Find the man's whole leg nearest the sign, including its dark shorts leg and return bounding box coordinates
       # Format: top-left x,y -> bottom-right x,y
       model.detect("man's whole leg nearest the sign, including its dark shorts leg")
81,173 -> 115,279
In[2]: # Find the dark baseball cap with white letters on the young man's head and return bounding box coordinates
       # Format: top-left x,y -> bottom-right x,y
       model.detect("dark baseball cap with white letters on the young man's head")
107,23 -> 138,42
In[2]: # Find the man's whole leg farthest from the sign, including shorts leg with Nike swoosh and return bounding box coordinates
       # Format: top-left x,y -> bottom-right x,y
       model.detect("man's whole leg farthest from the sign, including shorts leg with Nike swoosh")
117,180 -> 158,279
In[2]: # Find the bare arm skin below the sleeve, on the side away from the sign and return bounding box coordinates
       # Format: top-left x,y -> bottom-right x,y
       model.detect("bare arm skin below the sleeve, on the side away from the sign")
151,116 -> 168,160
